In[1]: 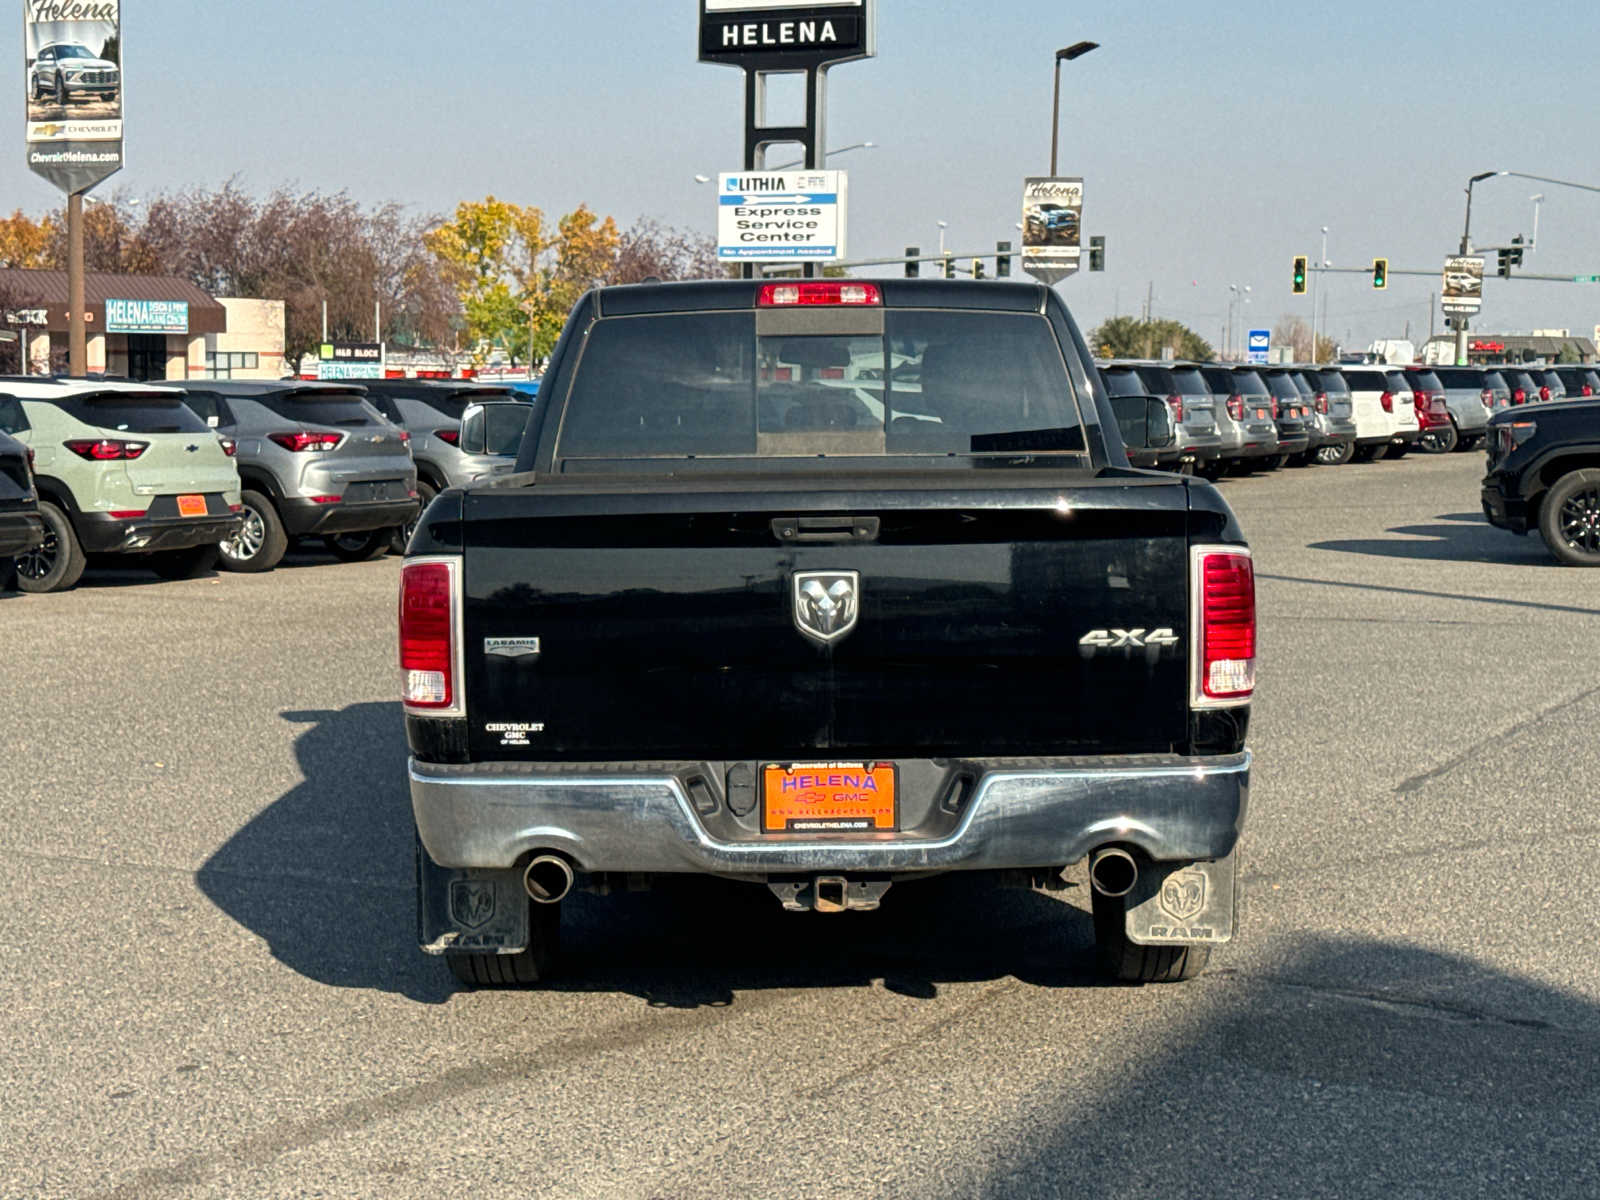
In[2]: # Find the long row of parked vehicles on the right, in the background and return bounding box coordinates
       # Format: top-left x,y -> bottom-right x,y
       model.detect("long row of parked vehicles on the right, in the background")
1098,358 -> 1600,478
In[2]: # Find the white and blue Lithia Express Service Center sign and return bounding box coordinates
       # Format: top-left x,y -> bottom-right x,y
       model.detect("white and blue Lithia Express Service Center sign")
717,171 -> 848,262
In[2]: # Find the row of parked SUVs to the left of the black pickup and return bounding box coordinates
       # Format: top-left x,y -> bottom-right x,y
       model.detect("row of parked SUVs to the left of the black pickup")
0,378 -> 531,592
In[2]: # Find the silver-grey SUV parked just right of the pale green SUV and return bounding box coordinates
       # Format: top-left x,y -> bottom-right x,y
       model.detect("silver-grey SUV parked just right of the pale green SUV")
176,379 -> 418,571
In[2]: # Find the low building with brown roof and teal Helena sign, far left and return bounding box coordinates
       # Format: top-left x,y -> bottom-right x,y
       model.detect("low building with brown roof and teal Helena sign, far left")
0,269 -> 283,381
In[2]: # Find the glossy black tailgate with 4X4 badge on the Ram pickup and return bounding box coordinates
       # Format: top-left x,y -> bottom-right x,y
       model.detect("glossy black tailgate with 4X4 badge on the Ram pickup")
462,474 -> 1189,762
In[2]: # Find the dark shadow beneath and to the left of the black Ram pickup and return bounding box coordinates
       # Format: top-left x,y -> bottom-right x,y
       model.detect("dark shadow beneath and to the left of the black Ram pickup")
197,702 -> 1101,1008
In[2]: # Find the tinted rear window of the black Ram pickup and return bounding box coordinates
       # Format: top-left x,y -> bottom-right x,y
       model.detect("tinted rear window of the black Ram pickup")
557,309 -> 1085,461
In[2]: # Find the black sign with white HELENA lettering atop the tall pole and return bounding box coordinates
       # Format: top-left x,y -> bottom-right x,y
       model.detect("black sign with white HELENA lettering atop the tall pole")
699,0 -> 874,70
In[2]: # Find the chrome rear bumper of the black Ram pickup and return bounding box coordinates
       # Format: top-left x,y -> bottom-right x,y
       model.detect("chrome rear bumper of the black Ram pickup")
408,750 -> 1251,877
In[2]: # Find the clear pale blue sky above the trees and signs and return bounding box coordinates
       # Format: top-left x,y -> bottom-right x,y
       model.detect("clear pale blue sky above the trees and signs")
0,0 -> 1600,356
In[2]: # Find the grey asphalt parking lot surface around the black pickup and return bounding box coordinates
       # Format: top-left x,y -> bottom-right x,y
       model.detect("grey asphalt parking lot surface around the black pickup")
0,454 -> 1600,1198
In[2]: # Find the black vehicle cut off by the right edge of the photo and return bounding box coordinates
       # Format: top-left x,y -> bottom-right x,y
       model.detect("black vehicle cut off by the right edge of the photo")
1483,398 -> 1600,566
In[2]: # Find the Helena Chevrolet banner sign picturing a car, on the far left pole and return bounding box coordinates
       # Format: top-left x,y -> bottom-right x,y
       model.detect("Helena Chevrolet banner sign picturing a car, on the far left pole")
22,0 -> 123,195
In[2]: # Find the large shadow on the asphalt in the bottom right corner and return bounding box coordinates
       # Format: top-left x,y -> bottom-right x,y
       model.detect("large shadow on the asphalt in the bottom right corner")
950,936 -> 1600,1200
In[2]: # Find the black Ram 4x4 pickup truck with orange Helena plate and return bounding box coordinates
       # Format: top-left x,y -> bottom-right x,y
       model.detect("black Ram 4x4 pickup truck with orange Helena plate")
400,280 -> 1256,984
